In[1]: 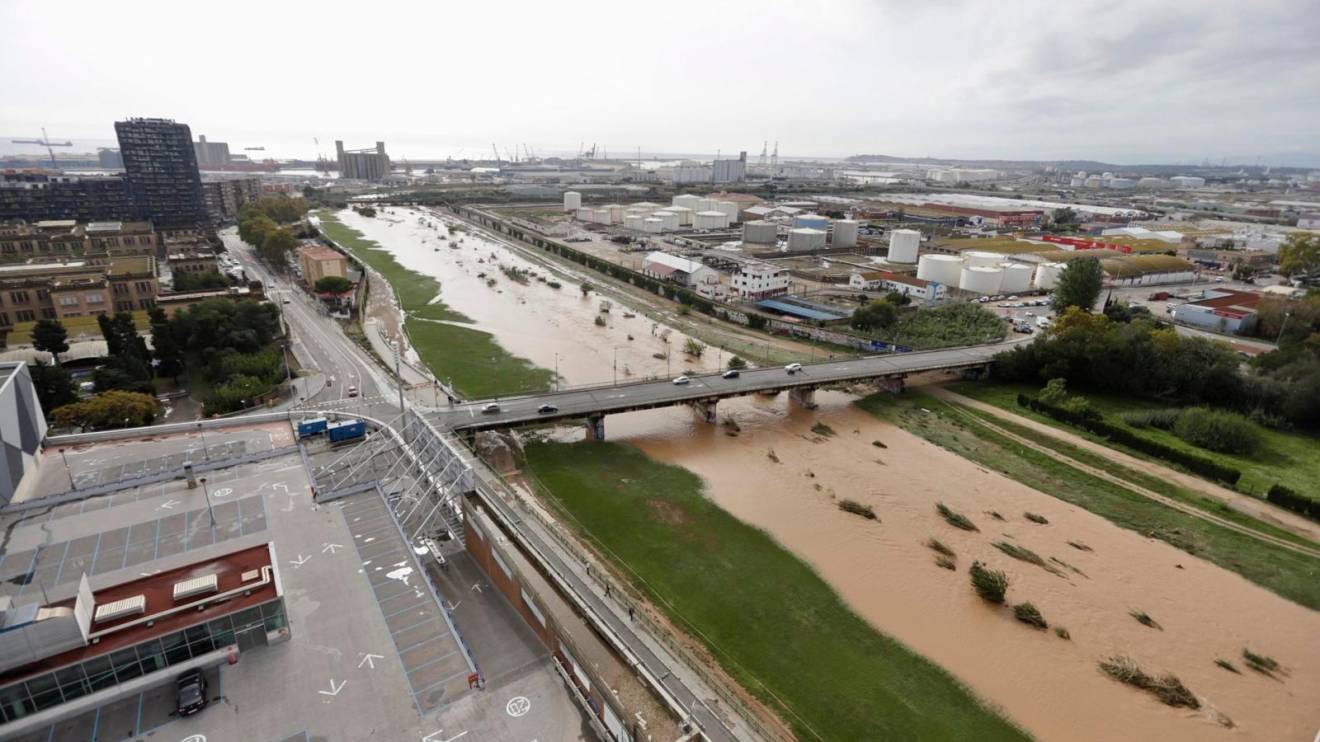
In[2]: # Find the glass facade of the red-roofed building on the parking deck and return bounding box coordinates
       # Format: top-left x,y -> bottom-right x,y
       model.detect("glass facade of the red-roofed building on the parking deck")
0,599 -> 288,721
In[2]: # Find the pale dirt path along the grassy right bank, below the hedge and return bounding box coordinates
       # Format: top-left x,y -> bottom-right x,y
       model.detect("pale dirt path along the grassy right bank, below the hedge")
927,387 -> 1320,557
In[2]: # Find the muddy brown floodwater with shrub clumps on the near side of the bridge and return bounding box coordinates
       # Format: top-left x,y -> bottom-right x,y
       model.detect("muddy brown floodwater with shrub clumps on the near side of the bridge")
596,392 -> 1320,742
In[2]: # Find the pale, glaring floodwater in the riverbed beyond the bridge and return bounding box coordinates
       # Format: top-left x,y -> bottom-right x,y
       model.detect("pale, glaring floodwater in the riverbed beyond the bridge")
335,207 -> 727,386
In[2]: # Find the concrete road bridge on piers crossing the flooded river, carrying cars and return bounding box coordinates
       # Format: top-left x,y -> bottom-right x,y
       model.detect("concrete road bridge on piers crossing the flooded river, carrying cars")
428,345 -> 1007,440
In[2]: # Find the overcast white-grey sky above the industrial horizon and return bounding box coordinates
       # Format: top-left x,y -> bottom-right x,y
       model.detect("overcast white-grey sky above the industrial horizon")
0,0 -> 1320,162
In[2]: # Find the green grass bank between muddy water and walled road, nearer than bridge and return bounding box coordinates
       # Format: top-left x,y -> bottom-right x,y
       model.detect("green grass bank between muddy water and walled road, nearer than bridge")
527,442 -> 1026,742
